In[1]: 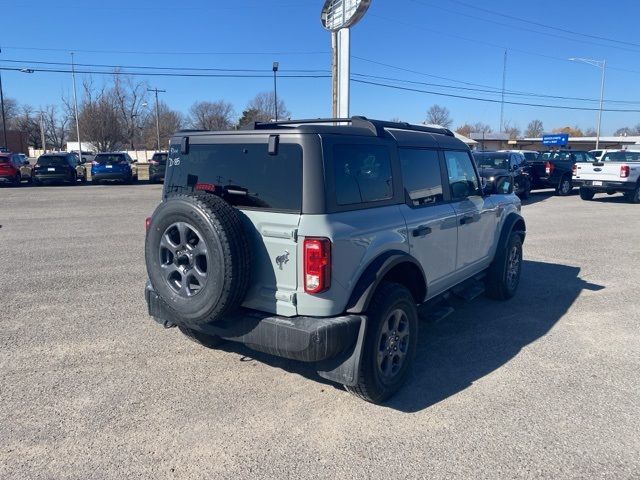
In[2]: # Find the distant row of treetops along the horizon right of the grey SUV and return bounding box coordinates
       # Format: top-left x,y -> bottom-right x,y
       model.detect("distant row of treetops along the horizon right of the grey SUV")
425,105 -> 640,139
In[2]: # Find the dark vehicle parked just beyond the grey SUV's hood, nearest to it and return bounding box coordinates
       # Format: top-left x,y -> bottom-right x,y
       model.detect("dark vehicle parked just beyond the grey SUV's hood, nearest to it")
473,151 -> 531,199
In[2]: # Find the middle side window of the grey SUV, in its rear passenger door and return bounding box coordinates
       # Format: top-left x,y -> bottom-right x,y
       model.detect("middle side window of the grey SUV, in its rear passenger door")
398,148 -> 443,207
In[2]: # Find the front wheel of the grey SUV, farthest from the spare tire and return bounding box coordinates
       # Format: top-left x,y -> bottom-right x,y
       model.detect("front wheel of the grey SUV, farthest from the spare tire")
487,233 -> 522,300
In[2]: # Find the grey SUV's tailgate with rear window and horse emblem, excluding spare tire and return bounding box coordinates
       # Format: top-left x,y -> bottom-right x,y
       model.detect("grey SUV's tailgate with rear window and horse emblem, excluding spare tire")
164,135 -> 302,316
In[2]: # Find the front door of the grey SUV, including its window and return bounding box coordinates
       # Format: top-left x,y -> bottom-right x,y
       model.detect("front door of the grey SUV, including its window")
444,150 -> 498,277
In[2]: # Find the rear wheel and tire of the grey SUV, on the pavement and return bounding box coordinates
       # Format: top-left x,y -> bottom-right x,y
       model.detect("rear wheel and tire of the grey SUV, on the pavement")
346,282 -> 418,403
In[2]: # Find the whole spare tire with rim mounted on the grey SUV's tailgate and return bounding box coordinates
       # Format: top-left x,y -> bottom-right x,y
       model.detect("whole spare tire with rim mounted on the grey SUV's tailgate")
145,193 -> 251,326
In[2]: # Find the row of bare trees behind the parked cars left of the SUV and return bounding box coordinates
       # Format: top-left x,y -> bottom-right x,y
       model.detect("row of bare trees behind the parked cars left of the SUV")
0,72 -> 291,151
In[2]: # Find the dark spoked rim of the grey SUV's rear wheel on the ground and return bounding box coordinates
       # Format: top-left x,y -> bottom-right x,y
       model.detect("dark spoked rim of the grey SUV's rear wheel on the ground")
377,309 -> 410,381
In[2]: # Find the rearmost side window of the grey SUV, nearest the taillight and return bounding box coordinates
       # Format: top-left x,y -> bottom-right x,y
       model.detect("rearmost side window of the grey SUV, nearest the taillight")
333,145 -> 393,205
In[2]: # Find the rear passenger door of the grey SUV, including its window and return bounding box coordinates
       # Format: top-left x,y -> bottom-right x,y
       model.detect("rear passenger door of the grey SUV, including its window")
398,148 -> 458,297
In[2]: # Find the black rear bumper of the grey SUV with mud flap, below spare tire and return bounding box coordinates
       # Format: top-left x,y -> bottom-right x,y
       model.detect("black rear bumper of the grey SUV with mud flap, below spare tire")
145,282 -> 366,385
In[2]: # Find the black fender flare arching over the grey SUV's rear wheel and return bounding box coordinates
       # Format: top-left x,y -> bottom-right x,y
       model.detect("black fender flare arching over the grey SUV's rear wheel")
345,250 -> 427,313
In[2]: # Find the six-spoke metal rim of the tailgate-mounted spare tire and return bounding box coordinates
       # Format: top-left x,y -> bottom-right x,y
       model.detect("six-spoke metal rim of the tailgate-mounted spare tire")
158,222 -> 209,298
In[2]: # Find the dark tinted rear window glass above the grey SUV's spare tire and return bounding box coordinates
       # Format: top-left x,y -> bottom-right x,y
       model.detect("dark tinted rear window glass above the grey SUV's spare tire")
165,143 -> 302,213
